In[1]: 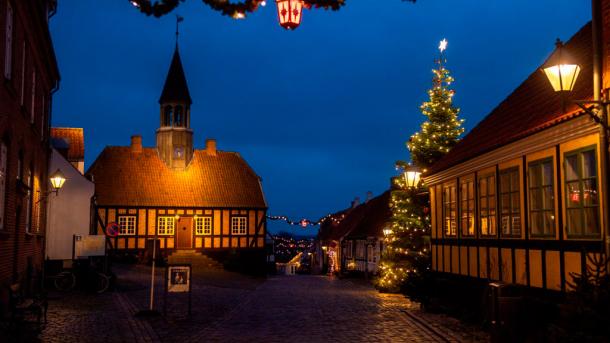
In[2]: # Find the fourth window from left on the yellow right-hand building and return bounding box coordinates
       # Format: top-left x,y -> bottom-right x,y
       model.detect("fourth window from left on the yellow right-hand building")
500,168 -> 521,236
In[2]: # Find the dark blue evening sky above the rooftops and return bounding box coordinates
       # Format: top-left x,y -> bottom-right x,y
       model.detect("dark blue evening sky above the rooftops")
51,0 -> 590,234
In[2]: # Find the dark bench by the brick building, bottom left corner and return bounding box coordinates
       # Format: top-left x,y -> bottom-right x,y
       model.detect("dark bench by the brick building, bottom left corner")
8,283 -> 48,329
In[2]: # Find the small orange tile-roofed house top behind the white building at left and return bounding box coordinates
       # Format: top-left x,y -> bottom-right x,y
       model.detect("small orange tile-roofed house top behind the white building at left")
51,127 -> 85,174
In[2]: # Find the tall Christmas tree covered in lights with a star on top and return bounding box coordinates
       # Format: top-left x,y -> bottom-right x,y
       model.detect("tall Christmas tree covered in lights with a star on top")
377,40 -> 464,301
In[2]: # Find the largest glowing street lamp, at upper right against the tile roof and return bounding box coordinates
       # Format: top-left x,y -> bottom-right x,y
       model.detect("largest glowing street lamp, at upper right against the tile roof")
542,38 -> 580,92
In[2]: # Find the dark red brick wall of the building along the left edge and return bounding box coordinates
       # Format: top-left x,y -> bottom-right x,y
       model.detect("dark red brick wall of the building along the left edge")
0,0 -> 59,303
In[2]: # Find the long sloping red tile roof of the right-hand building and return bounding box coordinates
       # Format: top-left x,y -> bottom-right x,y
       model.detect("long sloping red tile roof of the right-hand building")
426,23 -> 593,175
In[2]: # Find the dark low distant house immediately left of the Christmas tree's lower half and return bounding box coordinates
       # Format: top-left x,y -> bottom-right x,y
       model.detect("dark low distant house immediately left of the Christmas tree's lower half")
342,191 -> 392,274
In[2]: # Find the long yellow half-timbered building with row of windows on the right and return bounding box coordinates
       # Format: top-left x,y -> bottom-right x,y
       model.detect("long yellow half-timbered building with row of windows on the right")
425,20 -> 610,291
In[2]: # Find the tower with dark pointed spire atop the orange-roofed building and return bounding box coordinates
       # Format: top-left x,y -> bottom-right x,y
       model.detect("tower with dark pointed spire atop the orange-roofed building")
157,44 -> 193,169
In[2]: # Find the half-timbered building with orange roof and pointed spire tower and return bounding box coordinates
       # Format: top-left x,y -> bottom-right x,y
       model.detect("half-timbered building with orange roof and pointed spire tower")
87,47 -> 267,263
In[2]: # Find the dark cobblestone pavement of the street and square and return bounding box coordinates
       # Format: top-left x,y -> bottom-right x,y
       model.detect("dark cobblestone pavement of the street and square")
29,266 -> 487,343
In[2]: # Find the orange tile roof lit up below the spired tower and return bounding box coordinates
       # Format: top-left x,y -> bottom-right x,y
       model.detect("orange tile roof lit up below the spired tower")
86,147 -> 267,208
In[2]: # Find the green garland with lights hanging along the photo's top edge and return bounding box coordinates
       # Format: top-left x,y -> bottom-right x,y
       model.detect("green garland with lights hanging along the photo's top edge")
129,0 -> 346,18
